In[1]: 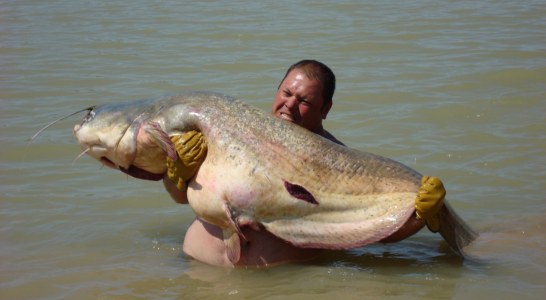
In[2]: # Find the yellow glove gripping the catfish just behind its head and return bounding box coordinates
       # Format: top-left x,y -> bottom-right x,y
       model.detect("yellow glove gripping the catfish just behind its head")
167,130 -> 207,190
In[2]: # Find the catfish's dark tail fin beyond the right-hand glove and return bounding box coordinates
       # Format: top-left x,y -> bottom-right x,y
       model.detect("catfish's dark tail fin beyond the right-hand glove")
439,201 -> 478,257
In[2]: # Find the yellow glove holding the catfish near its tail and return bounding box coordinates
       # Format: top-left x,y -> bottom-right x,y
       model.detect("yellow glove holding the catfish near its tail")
415,176 -> 446,232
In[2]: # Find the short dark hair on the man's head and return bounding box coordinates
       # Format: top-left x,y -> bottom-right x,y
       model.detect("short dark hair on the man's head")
279,59 -> 336,107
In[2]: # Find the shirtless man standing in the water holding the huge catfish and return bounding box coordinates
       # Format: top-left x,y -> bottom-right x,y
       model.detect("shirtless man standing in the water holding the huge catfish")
164,60 -> 443,266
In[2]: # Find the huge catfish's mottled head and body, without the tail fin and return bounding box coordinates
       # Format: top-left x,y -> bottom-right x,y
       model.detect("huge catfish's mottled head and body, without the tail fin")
74,92 -> 422,249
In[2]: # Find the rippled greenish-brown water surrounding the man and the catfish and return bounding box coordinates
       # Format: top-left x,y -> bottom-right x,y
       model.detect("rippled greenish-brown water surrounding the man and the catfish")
0,0 -> 546,299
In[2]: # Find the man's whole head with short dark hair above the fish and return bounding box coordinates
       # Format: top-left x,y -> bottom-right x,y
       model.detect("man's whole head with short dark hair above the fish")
272,60 -> 336,134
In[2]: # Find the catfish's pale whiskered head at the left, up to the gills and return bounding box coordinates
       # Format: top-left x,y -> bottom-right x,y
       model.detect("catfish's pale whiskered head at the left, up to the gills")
74,100 -> 177,180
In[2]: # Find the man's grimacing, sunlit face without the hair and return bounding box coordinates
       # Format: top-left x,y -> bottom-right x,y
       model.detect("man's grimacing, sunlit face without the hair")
272,69 -> 331,133
